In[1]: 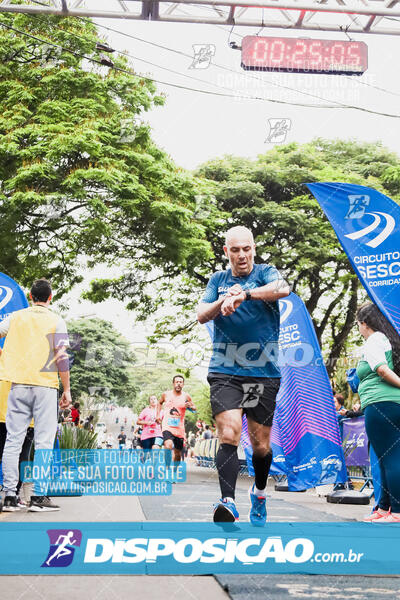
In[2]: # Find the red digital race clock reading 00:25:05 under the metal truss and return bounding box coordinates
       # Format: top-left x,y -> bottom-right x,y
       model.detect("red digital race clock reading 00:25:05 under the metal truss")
242,35 -> 368,75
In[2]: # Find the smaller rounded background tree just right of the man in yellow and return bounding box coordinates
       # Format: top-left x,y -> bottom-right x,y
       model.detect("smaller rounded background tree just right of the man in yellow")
68,318 -> 138,406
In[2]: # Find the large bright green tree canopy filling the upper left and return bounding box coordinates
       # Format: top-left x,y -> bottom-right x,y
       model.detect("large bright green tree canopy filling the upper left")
0,14 -> 209,294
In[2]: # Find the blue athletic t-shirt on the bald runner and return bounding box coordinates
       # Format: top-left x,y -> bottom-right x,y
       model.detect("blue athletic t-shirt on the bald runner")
202,264 -> 282,377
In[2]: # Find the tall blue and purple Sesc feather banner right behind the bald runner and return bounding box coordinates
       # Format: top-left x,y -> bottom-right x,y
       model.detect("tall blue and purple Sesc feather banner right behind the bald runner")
207,293 -> 347,491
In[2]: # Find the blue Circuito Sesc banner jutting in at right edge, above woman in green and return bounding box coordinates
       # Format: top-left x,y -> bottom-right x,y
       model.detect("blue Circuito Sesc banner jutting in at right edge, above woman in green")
306,183 -> 400,333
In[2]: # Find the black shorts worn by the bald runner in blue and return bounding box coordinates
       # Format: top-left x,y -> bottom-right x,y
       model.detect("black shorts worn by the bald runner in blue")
207,373 -> 281,427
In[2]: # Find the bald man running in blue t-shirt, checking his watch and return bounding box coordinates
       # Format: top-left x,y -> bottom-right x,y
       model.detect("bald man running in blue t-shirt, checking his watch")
197,226 -> 290,527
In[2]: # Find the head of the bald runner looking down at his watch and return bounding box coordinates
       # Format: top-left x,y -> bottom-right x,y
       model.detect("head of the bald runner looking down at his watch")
224,225 -> 256,277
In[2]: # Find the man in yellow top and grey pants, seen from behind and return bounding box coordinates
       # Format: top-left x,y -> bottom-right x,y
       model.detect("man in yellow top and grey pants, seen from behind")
0,279 -> 71,512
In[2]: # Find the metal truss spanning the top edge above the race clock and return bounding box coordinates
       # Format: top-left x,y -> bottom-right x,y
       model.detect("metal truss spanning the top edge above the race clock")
0,0 -> 400,35
